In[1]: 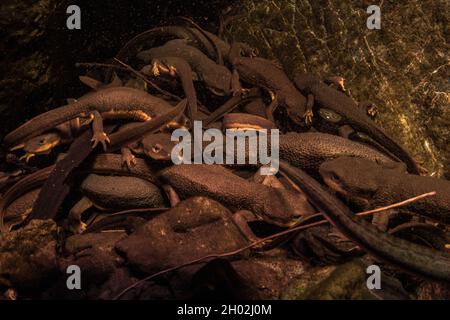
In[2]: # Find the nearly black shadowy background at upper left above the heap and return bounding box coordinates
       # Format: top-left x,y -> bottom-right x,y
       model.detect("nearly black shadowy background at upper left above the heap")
0,0 -> 235,138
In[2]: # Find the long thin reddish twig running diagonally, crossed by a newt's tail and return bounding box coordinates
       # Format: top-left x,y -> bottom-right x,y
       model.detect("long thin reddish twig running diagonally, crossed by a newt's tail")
113,191 -> 436,300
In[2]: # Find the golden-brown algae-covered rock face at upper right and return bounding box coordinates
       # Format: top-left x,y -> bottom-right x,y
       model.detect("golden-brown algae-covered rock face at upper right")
229,0 -> 450,177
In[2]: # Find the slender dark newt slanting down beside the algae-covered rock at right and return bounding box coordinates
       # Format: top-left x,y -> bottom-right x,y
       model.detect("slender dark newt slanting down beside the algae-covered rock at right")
294,74 -> 419,174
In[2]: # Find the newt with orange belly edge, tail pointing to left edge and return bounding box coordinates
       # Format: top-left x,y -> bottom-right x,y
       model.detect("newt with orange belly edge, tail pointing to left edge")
4,87 -> 178,150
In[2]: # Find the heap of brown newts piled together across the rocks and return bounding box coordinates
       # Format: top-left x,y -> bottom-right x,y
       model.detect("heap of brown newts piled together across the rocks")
0,19 -> 450,295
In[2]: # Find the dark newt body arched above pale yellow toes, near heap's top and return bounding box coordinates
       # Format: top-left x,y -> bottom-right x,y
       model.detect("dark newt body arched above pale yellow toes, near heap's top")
137,39 -> 231,96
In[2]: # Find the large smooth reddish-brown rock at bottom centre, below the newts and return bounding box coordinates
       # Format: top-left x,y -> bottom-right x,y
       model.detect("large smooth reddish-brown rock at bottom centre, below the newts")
116,197 -> 247,274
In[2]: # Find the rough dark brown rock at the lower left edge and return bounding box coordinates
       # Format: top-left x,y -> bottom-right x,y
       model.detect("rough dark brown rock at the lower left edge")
0,220 -> 57,289
